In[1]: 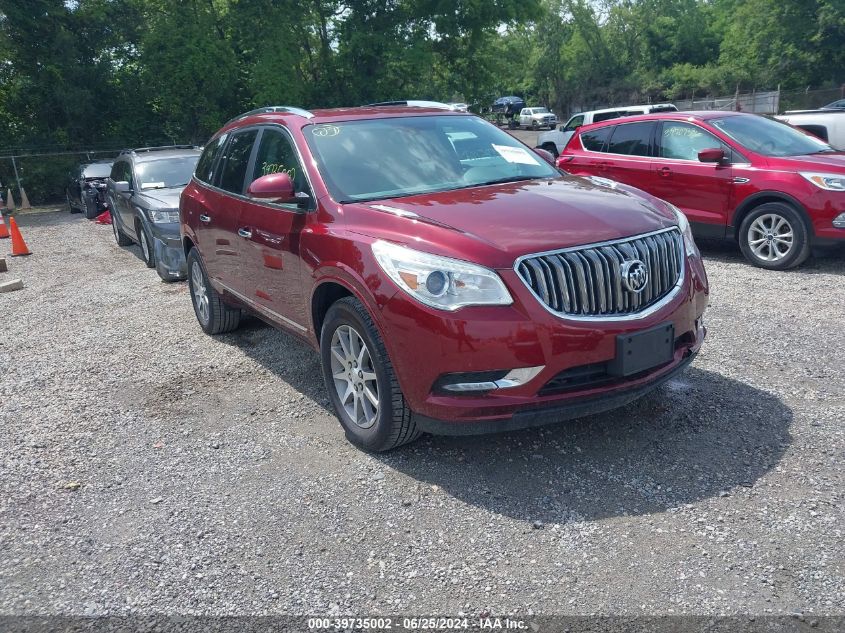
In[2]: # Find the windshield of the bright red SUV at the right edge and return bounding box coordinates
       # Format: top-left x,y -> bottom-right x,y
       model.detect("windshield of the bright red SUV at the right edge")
710,116 -> 835,156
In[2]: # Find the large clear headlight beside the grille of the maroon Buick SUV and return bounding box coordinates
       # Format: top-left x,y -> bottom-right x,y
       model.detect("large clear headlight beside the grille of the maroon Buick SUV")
372,241 -> 513,310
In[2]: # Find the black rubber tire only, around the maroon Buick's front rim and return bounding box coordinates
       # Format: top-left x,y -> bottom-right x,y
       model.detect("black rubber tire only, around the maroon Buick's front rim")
320,297 -> 422,452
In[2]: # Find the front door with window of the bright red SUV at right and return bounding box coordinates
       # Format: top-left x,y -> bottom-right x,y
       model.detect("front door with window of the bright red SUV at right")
643,121 -> 733,232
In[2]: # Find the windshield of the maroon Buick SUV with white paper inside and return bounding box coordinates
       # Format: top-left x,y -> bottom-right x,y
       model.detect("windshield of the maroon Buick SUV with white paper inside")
303,116 -> 559,202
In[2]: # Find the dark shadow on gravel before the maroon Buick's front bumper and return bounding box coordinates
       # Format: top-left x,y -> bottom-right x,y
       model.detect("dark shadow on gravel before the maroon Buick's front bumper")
376,369 -> 792,523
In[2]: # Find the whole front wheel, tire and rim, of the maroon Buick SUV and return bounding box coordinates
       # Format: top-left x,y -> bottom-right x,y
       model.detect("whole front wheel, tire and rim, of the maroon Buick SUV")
320,297 -> 421,452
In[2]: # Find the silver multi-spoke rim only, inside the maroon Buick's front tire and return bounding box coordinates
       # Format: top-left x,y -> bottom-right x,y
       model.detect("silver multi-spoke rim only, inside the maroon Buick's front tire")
331,325 -> 379,429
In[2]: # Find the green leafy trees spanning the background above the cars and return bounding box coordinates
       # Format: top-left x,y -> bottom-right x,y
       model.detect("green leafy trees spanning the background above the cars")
0,0 -> 845,200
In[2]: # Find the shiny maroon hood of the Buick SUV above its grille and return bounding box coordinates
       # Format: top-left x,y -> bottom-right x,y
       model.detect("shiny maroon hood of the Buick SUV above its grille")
347,176 -> 677,268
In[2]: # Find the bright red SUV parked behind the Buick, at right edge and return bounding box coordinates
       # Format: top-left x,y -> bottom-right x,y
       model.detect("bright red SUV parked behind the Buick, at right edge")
558,112 -> 845,270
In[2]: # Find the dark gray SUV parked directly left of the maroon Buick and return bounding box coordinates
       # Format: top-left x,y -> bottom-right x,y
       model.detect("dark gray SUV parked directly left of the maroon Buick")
108,145 -> 200,281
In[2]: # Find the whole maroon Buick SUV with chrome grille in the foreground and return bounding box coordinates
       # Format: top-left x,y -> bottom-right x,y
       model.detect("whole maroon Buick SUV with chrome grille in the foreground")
180,107 -> 708,450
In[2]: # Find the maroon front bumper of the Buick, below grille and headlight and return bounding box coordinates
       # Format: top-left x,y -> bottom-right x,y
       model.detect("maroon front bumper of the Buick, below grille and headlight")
381,252 -> 708,434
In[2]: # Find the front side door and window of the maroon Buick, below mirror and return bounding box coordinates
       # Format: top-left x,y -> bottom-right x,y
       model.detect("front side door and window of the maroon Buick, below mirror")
238,126 -> 313,331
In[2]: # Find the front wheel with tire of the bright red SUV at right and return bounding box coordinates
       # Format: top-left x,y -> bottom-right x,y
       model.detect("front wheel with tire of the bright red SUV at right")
738,202 -> 810,270
